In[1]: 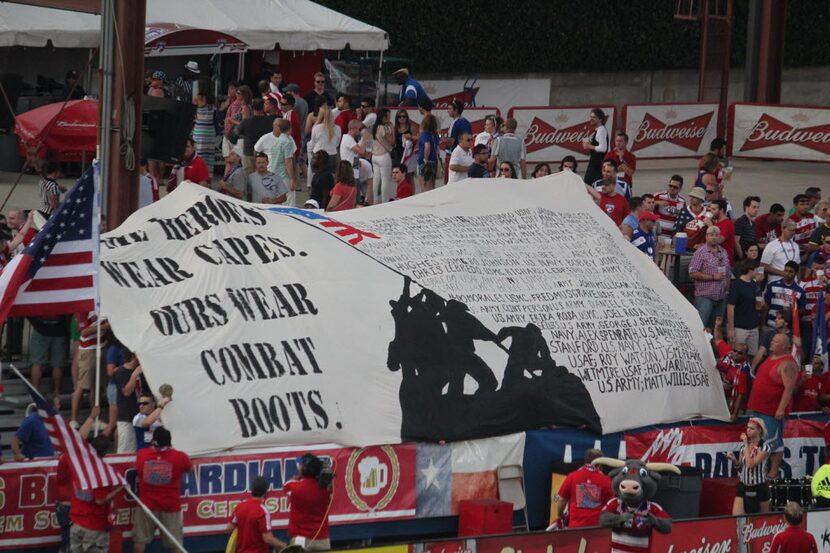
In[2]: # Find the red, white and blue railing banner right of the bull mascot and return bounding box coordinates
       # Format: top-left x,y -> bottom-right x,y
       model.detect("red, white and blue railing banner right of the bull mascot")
625,418 -> 824,478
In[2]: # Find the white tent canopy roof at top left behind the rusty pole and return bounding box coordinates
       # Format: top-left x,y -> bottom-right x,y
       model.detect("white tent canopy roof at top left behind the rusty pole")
0,0 -> 389,50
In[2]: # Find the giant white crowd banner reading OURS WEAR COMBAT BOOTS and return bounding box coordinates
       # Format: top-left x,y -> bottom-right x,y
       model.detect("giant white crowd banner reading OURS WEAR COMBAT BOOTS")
101,174 -> 727,452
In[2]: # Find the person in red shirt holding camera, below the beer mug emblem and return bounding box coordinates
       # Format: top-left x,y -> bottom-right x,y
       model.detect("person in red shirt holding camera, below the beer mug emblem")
283,453 -> 333,551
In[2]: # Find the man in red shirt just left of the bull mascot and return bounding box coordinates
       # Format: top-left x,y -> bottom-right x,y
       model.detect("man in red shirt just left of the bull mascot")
556,449 -> 614,528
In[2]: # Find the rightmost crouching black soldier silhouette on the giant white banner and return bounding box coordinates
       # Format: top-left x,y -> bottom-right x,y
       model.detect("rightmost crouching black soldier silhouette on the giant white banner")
498,323 -> 557,390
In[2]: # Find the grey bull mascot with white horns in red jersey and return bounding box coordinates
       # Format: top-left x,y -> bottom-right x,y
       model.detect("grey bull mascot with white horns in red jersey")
593,457 -> 680,553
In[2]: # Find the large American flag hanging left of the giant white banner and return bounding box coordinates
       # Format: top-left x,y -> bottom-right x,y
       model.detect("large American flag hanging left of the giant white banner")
0,166 -> 99,323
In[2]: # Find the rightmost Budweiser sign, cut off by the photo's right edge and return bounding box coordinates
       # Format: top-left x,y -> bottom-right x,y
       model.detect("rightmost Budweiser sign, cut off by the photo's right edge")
730,103 -> 830,162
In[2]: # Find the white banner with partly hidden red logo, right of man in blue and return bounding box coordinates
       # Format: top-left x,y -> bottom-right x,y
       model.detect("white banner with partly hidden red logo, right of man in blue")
421,79 -> 550,117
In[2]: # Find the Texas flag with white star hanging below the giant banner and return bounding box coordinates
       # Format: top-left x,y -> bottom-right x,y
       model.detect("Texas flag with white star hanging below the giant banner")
416,432 -> 525,518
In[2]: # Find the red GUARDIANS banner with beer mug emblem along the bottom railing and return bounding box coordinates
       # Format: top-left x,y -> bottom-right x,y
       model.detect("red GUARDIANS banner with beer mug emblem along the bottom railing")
0,444 -> 416,549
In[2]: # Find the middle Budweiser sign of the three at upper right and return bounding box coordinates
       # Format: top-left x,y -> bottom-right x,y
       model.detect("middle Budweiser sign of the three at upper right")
622,103 -> 720,159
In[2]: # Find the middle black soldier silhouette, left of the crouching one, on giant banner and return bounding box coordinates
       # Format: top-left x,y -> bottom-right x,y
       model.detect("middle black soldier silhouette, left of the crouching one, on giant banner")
443,300 -> 498,398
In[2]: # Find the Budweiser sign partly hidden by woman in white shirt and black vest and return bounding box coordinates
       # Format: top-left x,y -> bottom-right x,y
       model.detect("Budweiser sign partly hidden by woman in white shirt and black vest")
508,106 -> 616,163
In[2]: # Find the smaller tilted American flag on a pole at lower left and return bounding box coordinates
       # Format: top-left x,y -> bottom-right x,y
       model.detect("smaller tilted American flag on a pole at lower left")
12,367 -> 124,490
